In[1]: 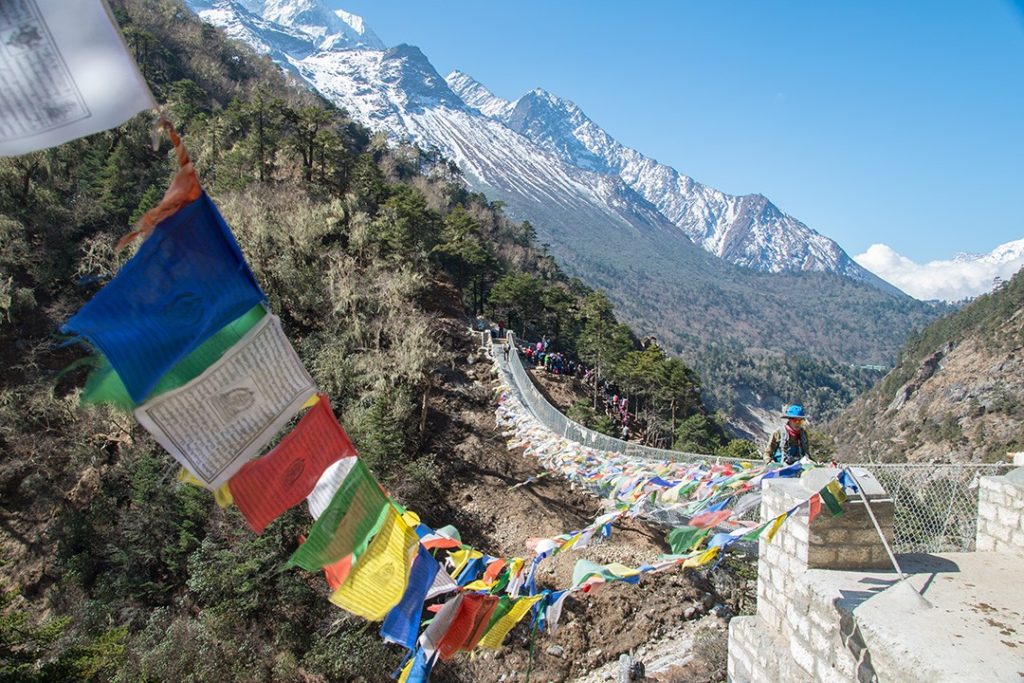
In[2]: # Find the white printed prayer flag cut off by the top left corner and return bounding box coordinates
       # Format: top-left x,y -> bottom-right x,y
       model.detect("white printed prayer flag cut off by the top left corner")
0,0 -> 157,157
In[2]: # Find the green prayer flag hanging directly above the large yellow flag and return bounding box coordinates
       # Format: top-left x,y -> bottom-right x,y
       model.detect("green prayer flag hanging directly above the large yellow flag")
288,458 -> 389,571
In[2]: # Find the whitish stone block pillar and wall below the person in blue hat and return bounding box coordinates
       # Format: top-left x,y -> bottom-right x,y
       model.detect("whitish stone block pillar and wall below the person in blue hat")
729,469 -> 893,683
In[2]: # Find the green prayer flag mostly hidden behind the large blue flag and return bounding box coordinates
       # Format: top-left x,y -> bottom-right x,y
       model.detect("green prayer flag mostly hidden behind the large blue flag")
81,304 -> 266,413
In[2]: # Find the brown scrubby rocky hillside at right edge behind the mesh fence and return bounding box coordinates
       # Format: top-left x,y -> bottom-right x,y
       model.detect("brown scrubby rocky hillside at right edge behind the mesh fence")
828,271 -> 1024,462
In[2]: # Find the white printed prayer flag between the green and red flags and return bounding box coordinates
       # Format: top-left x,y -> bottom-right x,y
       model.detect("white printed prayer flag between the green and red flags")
135,314 -> 316,490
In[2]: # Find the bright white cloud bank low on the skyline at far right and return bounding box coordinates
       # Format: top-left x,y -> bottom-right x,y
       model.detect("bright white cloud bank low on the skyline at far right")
853,240 -> 1024,301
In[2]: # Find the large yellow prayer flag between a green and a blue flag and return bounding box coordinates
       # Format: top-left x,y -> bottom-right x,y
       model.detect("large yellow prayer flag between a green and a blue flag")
331,506 -> 419,622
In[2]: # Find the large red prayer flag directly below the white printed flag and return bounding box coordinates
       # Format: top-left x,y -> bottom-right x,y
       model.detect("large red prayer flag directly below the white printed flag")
227,394 -> 355,533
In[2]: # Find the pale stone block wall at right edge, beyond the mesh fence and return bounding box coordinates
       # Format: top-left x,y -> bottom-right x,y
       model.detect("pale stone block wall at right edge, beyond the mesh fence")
977,454 -> 1024,556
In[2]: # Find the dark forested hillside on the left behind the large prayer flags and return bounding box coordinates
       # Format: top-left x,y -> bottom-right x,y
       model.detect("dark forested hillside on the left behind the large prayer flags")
0,0 -> 736,681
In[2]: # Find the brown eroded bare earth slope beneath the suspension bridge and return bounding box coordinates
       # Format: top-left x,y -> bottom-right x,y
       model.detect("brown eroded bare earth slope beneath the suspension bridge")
411,346 -> 753,681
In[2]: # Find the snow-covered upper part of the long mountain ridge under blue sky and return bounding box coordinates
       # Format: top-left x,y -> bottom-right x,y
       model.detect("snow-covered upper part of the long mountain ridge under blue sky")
189,0 -> 891,291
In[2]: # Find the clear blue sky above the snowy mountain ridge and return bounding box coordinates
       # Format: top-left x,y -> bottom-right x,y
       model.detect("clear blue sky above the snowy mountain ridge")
329,0 -> 1024,263
